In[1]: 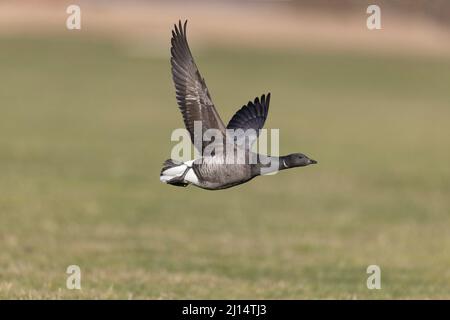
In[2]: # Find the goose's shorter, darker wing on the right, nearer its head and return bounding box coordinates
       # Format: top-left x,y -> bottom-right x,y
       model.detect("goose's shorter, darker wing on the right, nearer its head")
227,93 -> 270,146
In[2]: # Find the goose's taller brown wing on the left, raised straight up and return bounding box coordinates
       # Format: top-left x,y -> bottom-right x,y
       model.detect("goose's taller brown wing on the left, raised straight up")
170,21 -> 225,152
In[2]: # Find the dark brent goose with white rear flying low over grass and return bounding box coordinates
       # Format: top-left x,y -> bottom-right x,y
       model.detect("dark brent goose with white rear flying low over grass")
160,21 -> 317,190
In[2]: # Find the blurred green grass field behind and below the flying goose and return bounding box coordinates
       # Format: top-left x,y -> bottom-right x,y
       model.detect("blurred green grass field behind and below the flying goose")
0,37 -> 450,299
